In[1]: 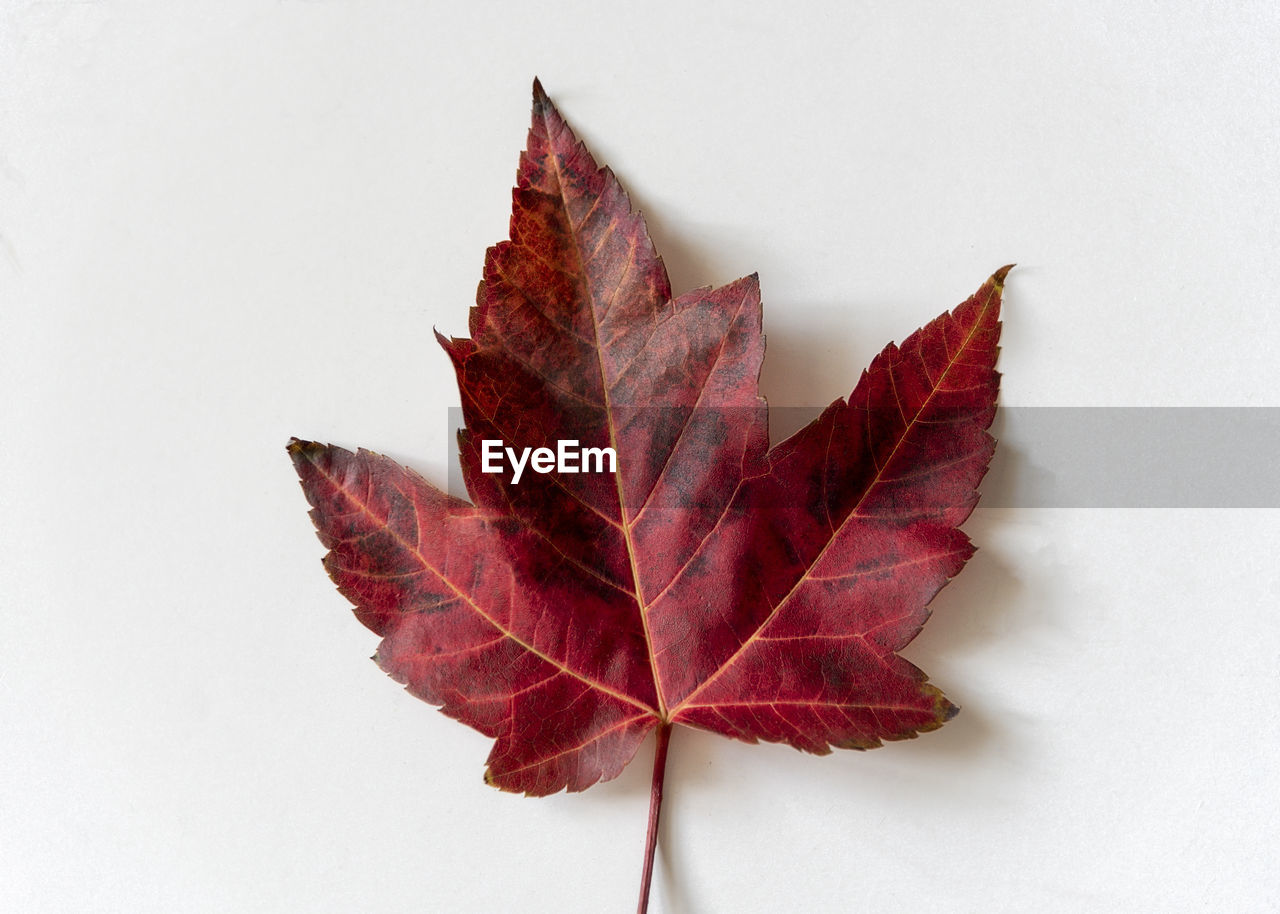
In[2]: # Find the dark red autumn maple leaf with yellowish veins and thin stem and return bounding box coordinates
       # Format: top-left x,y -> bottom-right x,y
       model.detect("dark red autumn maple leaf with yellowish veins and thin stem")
289,82 -> 1009,906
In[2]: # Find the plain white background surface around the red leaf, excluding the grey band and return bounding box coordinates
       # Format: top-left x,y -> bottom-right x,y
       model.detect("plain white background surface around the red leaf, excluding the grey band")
0,0 -> 1280,913
